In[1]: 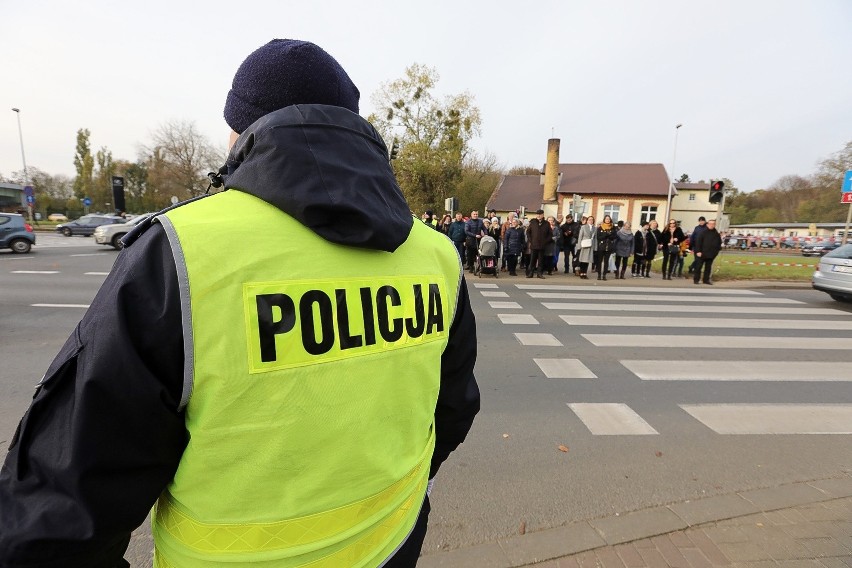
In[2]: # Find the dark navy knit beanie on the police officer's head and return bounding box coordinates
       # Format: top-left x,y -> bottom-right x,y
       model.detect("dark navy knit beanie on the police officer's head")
225,39 -> 361,134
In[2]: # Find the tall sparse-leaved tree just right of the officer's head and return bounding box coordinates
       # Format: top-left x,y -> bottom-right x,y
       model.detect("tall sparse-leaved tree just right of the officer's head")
368,63 -> 481,211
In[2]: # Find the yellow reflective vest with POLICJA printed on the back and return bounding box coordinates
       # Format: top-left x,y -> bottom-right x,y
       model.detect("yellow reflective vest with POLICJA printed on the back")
153,190 -> 461,568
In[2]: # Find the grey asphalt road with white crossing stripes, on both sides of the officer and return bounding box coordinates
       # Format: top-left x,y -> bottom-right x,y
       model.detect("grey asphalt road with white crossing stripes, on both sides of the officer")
0,235 -> 852,566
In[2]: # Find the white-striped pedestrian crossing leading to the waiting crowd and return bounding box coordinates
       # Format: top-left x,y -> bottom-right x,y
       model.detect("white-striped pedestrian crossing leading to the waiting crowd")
473,283 -> 852,436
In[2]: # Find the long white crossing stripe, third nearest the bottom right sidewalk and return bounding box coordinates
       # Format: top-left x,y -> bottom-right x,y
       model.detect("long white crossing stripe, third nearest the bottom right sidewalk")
581,333 -> 852,350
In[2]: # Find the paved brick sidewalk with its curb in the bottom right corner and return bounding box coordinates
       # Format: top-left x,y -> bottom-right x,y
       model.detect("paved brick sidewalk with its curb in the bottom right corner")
417,478 -> 852,568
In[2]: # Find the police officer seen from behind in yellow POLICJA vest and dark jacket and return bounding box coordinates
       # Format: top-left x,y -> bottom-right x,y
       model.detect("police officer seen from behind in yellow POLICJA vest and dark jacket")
0,40 -> 479,567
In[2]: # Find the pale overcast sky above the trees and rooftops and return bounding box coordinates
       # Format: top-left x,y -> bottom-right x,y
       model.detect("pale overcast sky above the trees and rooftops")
0,0 -> 852,191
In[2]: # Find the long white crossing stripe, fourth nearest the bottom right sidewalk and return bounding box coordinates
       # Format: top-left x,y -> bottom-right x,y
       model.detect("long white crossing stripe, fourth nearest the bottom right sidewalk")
559,315 -> 852,330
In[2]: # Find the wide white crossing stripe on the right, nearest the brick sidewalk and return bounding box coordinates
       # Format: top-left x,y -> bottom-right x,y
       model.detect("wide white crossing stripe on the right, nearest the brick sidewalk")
679,404 -> 852,434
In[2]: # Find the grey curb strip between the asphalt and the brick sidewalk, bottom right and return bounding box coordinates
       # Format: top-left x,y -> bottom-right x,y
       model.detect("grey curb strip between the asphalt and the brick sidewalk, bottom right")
417,477 -> 852,568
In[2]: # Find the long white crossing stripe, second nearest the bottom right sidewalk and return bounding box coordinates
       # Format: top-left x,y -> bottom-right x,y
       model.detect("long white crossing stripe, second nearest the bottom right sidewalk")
620,360 -> 852,382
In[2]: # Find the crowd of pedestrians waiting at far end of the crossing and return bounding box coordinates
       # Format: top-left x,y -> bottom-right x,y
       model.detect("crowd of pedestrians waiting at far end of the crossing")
430,209 -> 722,284
